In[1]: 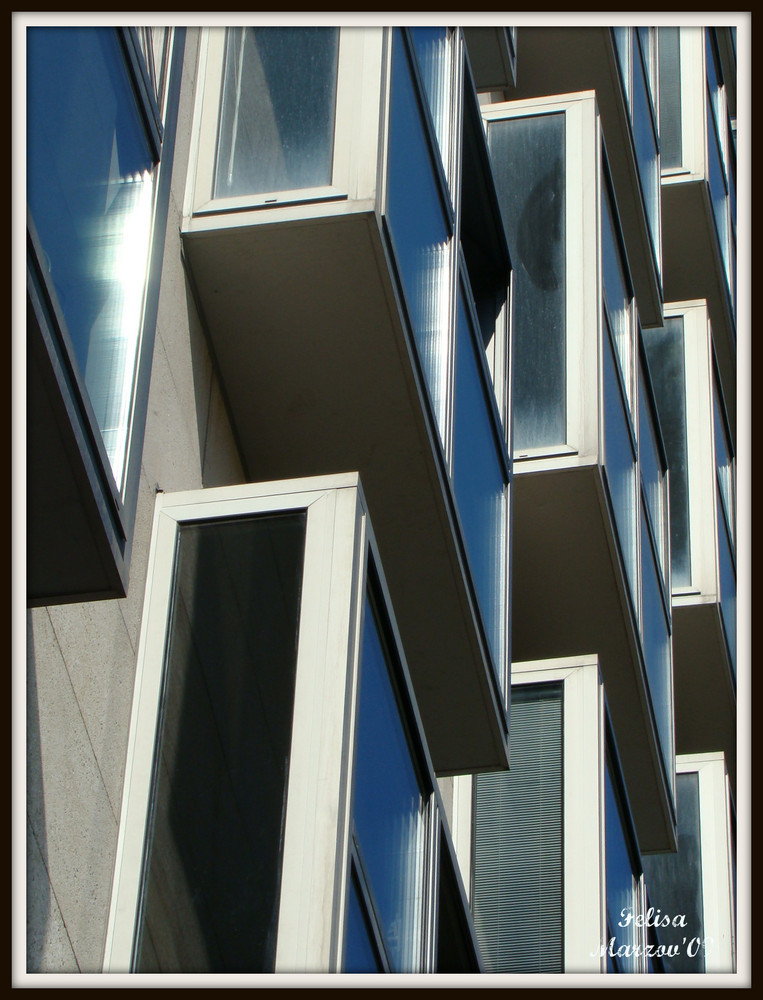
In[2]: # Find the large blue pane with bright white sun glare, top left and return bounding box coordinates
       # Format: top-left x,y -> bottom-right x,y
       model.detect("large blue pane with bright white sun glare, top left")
27,28 -> 154,485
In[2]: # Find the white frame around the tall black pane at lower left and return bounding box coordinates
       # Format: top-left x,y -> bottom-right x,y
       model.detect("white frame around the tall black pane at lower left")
103,473 -> 478,972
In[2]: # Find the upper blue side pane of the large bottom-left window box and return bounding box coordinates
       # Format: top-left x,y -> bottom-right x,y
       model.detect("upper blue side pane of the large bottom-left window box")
353,600 -> 424,972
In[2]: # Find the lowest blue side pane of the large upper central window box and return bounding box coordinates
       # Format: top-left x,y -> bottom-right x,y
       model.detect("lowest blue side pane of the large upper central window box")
453,295 -> 506,669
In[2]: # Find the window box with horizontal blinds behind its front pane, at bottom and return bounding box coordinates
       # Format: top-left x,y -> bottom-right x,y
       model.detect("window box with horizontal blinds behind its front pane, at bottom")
453,656 -> 664,974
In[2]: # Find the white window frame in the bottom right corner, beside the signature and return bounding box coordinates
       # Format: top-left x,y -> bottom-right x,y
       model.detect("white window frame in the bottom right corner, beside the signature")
676,751 -> 736,973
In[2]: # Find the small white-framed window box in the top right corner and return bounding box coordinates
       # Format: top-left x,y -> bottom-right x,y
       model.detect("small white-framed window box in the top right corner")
659,27 -> 736,440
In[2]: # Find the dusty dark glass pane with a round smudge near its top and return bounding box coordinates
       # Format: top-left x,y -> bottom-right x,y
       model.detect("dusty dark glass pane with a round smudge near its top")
488,114 -> 567,452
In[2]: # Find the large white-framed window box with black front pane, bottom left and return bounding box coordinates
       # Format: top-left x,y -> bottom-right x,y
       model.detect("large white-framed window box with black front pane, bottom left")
104,474 -> 481,973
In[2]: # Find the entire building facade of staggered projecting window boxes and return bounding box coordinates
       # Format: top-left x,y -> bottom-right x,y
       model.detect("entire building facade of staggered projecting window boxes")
21,21 -> 749,975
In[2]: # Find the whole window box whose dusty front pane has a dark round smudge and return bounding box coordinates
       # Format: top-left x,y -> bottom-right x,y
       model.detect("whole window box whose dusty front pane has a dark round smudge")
483,93 -> 674,849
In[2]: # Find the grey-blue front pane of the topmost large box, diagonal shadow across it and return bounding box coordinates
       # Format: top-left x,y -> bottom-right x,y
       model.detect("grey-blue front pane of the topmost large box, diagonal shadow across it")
214,27 -> 339,198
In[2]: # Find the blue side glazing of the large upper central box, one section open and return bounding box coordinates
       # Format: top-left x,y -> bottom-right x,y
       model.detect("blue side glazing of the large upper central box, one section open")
385,29 -> 511,698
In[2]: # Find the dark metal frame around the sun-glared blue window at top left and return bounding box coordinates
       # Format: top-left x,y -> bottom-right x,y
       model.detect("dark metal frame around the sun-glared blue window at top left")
27,24 -> 185,607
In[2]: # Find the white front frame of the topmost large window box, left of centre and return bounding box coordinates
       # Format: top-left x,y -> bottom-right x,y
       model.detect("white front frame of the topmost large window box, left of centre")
184,27 -> 382,228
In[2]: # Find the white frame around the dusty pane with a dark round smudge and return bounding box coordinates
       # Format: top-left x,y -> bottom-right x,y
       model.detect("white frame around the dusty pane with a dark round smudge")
481,91 -> 601,472
